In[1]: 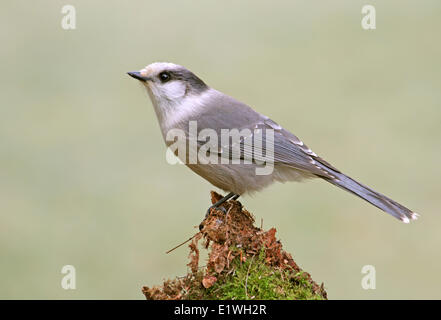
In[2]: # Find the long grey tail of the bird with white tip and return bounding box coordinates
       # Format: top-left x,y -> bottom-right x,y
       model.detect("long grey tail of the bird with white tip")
321,170 -> 419,223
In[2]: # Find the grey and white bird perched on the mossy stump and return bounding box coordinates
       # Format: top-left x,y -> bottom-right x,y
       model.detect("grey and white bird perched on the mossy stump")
127,62 -> 419,223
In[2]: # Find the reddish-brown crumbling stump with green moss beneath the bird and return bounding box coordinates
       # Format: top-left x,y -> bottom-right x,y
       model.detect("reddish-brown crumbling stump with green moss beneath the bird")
142,191 -> 327,300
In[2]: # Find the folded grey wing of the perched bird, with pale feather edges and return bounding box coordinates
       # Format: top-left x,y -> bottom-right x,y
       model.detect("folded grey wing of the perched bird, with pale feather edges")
184,90 -> 339,179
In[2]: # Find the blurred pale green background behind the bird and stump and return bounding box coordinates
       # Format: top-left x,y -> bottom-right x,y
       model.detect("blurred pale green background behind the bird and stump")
0,0 -> 441,299
